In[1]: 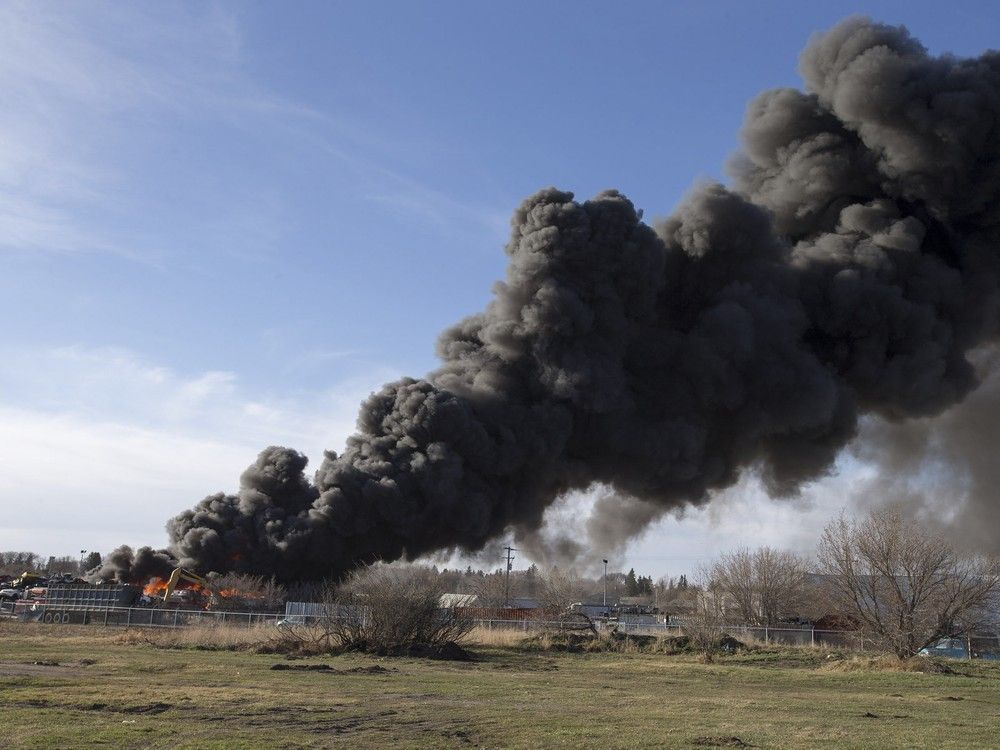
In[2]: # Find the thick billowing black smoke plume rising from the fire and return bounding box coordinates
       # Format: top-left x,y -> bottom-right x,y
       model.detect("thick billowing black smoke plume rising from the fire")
99,14 -> 1000,580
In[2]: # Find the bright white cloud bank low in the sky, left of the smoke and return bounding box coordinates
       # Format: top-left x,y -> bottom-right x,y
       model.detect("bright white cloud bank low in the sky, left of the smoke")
0,346 -> 397,554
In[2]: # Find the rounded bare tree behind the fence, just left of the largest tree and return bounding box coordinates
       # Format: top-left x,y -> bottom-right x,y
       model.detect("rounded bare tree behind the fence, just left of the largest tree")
708,547 -> 806,626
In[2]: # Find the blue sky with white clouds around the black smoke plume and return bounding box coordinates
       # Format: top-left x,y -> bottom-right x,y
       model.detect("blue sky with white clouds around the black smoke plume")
0,2 -> 1000,574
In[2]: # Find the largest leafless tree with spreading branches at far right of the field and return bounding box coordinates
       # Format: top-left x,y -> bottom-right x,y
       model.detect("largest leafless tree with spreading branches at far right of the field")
819,509 -> 1000,658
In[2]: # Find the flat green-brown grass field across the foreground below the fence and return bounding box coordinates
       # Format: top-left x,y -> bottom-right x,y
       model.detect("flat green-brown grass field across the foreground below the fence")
0,624 -> 1000,749
